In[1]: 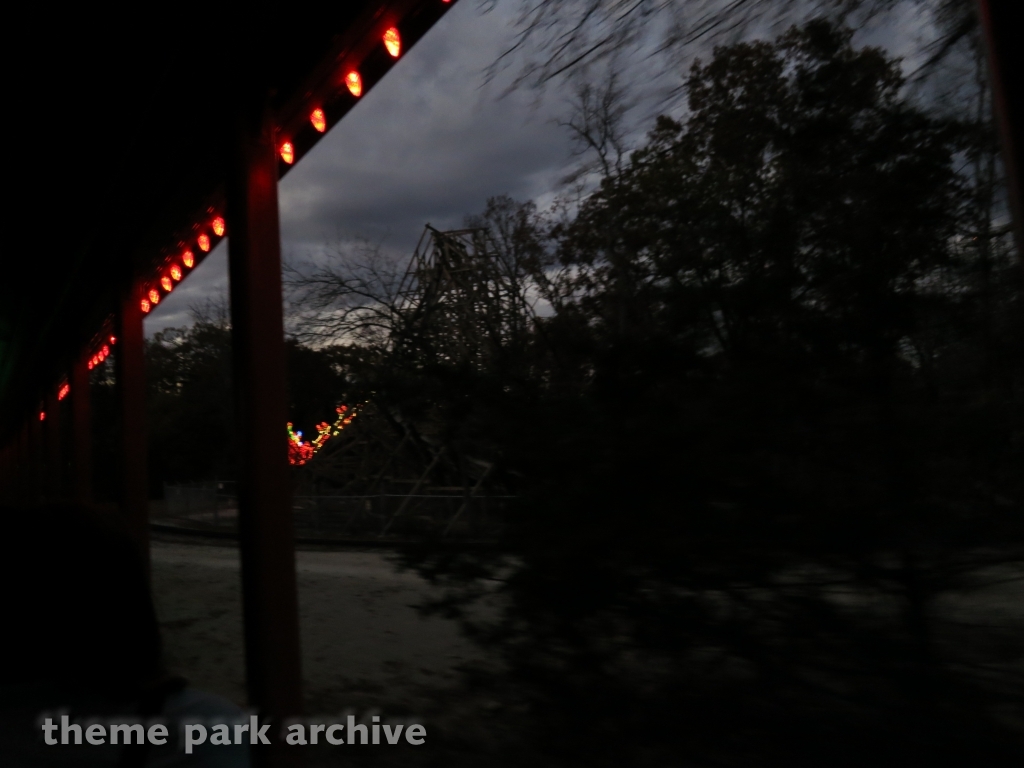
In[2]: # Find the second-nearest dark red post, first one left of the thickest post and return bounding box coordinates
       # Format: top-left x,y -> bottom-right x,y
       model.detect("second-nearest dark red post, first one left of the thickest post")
114,290 -> 150,572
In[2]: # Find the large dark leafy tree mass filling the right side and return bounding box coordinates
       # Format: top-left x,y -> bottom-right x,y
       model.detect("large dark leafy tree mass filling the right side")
409,22 -> 1022,765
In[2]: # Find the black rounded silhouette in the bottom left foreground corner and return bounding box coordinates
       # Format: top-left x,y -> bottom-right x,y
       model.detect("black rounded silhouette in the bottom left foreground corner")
0,505 -> 249,768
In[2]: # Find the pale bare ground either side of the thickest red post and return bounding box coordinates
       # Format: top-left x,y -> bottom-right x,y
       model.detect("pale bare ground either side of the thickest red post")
152,540 -> 491,714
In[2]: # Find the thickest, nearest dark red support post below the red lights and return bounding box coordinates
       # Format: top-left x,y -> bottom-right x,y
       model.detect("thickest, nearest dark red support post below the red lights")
226,88 -> 302,753
